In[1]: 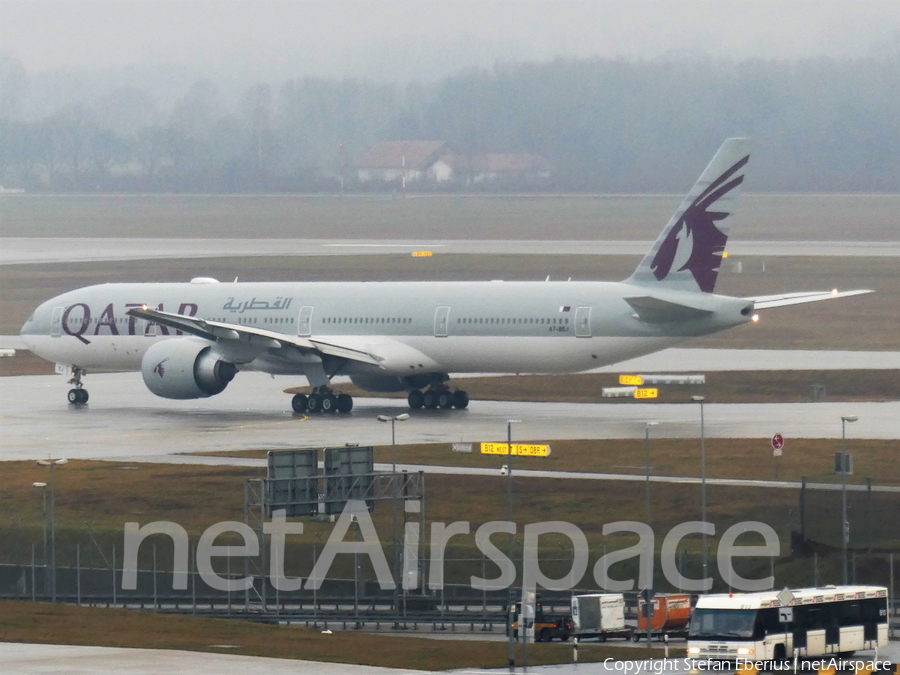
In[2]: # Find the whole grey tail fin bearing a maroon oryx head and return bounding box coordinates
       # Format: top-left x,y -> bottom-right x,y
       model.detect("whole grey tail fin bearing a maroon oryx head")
626,138 -> 750,293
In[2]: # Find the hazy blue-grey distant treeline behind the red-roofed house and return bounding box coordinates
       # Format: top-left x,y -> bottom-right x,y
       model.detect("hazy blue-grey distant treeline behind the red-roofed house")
0,55 -> 900,192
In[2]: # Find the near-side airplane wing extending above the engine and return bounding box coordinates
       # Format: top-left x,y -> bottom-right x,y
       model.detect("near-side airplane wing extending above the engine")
127,307 -> 383,368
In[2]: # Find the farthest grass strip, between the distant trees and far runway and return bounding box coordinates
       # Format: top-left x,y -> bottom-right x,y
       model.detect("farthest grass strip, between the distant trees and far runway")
0,193 -> 900,241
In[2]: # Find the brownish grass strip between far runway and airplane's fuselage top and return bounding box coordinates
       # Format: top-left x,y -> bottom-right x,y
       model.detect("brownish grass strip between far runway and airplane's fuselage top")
0,255 -> 900,350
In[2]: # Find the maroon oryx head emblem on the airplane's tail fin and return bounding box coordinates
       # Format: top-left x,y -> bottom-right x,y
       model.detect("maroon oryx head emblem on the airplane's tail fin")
650,155 -> 750,293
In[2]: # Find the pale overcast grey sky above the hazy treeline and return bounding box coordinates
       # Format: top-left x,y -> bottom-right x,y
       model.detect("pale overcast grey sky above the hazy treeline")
0,0 -> 900,80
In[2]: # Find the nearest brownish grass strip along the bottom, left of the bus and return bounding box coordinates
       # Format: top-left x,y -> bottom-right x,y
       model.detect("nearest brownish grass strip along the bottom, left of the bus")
0,600 -> 662,670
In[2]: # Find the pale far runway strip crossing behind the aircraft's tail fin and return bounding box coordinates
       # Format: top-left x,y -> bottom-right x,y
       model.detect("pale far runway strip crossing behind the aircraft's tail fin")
0,237 -> 900,265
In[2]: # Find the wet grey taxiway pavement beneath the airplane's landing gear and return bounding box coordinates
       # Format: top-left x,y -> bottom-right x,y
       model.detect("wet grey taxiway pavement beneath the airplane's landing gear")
0,373 -> 900,460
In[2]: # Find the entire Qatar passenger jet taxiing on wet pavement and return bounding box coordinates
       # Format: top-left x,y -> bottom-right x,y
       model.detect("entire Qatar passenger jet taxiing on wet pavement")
22,138 -> 869,413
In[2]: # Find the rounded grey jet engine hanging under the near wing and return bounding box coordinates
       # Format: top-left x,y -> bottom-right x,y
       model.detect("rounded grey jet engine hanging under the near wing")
141,337 -> 237,399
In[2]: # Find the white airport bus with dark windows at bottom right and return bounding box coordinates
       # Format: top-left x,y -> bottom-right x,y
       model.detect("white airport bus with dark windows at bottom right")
687,586 -> 888,661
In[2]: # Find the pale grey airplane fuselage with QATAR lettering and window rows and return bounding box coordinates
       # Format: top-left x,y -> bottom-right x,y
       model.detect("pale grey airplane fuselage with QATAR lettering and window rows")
22,281 -> 750,376
